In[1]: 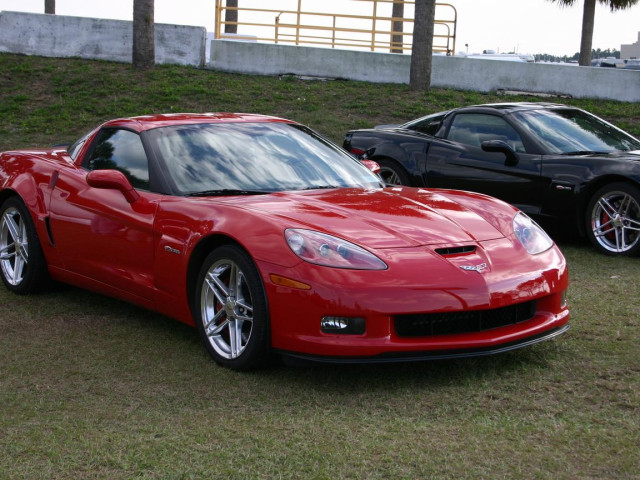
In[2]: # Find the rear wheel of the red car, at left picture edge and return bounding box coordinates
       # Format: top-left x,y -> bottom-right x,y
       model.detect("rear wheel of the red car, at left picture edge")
0,197 -> 49,295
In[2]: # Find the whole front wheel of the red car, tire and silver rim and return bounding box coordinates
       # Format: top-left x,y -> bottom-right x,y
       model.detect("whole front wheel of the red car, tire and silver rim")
193,245 -> 269,370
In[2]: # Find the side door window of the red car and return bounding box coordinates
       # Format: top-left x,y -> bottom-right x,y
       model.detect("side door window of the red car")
83,128 -> 149,190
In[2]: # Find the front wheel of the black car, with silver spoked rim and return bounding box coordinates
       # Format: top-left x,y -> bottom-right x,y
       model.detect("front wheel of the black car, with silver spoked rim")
586,182 -> 640,256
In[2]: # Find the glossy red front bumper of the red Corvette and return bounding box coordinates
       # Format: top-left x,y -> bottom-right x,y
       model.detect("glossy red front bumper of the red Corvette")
259,240 -> 569,363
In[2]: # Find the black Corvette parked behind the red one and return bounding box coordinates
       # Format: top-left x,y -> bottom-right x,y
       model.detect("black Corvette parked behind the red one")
344,103 -> 640,255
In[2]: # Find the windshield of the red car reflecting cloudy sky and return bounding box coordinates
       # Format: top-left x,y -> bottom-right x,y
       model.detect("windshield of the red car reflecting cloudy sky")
147,122 -> 381,195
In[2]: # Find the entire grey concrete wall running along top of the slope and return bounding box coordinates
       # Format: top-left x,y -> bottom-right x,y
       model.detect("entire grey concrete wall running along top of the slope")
0,12 -> 640,102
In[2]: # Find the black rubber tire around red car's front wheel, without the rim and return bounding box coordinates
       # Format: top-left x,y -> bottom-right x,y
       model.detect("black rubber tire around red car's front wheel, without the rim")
193,245 -> 270,370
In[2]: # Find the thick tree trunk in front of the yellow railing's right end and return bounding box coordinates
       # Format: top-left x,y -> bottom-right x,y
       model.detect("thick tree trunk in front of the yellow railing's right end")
409,0 -> 436,90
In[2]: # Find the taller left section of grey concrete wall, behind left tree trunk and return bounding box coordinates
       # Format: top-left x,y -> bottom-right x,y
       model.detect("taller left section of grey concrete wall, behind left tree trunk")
0,12 -> 206,67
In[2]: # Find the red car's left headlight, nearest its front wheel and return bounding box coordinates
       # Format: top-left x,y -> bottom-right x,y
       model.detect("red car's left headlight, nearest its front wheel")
284,228 -> 387,270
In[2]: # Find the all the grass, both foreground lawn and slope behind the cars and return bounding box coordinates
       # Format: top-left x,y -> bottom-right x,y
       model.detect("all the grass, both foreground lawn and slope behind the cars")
0,55 -> 640,479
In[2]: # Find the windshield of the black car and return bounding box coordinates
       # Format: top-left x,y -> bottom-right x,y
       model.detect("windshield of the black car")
513,108 -> 640,154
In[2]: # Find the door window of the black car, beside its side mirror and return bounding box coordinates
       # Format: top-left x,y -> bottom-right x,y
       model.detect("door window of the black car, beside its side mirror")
447,113 -> 526,153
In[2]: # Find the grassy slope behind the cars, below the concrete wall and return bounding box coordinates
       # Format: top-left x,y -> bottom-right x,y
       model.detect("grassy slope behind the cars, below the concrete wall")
0,54 -> 640,151
